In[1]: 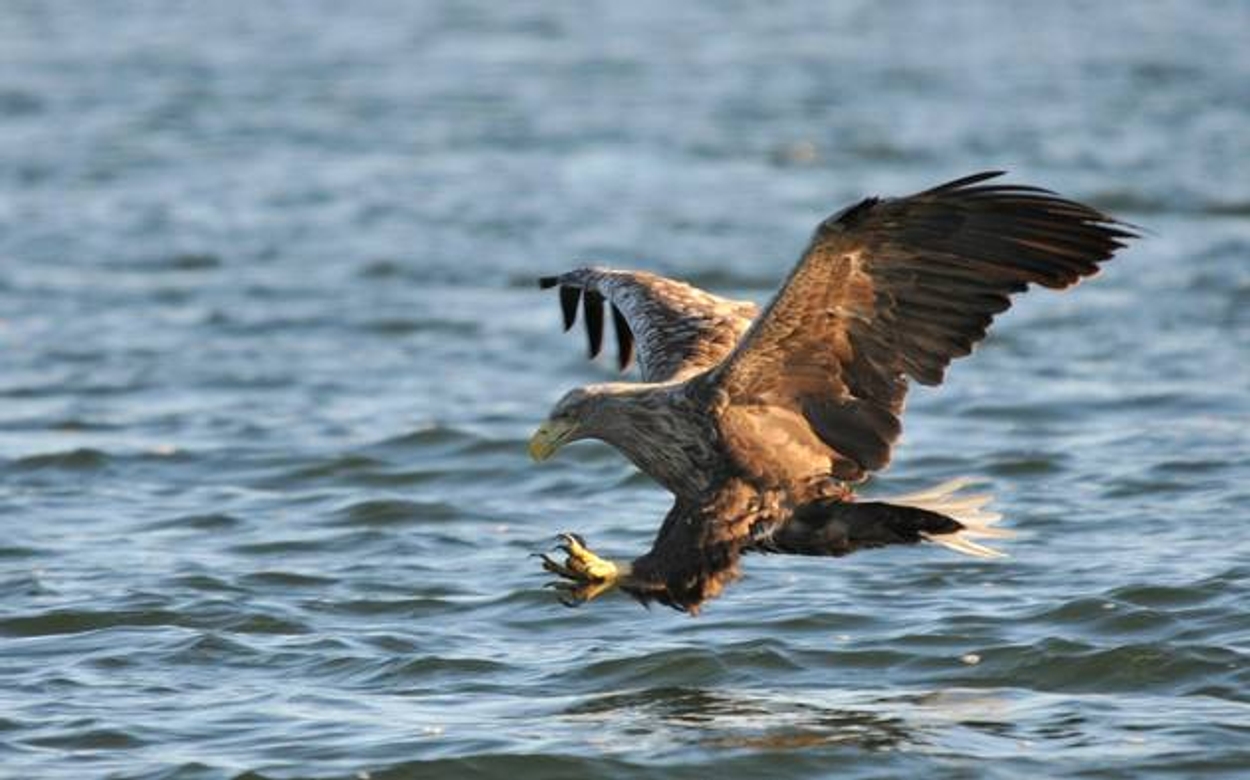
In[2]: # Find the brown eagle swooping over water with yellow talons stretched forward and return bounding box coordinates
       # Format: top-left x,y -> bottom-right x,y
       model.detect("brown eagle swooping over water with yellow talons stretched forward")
529,171 -> 1139,614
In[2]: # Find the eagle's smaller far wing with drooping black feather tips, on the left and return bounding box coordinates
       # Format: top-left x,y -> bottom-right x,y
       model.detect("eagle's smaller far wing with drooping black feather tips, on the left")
539,268 -> 758,381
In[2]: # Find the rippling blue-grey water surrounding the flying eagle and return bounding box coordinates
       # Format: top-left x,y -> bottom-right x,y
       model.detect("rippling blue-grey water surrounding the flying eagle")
0,0 -> 1250,780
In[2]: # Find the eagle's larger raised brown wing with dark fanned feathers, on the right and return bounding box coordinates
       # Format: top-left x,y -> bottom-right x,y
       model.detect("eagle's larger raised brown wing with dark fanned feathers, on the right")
711,171 -> 1136,480
